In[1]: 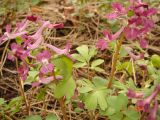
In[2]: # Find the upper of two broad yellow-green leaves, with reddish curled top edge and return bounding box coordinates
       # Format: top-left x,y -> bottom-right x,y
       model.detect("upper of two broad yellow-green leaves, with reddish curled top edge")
53,55 -> 73,80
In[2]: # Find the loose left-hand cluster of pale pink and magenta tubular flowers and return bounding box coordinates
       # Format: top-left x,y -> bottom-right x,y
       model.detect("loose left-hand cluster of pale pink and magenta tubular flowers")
0,16 -> 71,86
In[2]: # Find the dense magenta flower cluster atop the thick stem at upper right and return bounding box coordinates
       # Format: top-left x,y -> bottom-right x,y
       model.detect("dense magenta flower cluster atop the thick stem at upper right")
97,0 -> 157,53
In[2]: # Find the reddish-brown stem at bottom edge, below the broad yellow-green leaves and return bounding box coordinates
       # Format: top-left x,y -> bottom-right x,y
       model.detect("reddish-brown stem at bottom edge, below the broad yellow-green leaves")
58,97 -> 68,120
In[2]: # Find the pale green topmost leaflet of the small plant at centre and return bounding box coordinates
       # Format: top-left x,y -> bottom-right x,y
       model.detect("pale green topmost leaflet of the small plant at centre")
76,45 -> 89,62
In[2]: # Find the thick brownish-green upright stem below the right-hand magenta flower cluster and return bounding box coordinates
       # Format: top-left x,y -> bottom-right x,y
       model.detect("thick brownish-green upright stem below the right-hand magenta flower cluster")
107,34 -> 125,88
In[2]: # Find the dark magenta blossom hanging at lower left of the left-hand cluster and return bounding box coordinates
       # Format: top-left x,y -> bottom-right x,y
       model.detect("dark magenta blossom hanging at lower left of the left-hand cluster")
17,64 -> 29,80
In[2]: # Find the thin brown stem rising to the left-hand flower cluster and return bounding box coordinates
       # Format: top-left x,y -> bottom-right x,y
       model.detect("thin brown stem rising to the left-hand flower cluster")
16,58 -> 30,115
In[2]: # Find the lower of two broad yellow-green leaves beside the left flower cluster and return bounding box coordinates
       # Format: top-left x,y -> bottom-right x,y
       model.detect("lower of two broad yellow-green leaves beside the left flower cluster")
54,77 -> 76,99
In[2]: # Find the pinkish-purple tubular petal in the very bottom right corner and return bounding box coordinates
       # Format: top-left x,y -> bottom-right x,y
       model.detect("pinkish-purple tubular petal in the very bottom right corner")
147,100 -> 158,120
